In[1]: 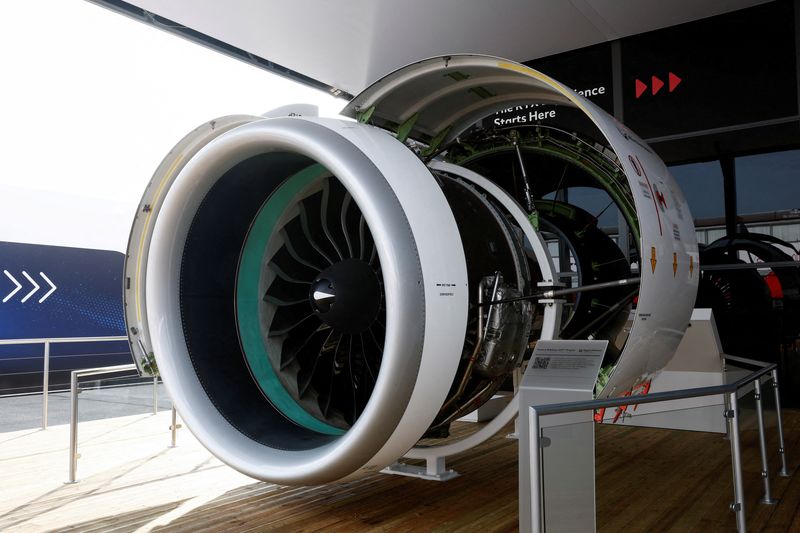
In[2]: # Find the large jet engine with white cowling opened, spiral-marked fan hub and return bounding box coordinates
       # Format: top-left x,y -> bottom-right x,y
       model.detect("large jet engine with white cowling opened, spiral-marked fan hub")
125,56 -> 697,484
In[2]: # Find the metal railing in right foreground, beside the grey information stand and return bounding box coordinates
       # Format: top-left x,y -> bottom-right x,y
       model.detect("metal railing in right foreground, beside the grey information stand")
528,355 -> 790,533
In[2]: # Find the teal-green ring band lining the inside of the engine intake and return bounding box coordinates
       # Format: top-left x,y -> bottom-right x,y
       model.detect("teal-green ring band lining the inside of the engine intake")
236,165 -> 344,435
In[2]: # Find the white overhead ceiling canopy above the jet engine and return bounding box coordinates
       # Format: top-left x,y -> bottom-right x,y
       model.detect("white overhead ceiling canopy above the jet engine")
93,0 -> 765,94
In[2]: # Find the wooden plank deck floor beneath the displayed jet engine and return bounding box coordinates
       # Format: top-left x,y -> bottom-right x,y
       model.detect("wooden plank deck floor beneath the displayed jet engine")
0,411 -> 800,533
